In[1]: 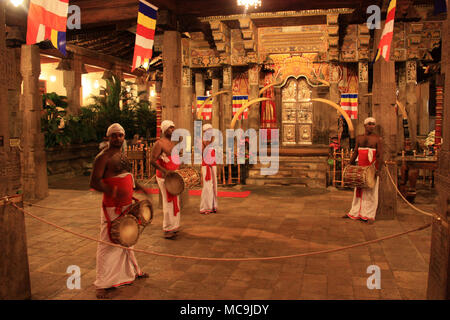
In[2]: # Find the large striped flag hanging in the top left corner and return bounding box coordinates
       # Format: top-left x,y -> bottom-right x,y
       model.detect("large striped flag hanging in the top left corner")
27,0 -> 69,55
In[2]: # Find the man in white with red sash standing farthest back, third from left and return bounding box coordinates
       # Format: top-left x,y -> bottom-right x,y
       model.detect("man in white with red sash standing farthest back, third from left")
200,124 -> 217,214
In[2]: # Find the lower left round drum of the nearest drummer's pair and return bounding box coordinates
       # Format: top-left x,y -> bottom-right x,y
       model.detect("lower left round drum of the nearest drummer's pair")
110,214 -> 139,247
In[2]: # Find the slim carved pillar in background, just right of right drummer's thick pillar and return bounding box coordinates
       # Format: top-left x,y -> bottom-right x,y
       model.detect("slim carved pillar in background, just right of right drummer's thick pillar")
405,60 -> 418,149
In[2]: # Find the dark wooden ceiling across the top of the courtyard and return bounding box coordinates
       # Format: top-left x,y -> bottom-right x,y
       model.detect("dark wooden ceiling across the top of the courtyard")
6,0 -> 440,62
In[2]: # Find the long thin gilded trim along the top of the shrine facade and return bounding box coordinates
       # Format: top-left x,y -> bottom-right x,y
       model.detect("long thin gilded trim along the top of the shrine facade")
199,8 -> 355,22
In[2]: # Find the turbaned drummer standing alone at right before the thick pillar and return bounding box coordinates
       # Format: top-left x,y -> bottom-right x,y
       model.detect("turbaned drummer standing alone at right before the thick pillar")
344,117 -> 383,223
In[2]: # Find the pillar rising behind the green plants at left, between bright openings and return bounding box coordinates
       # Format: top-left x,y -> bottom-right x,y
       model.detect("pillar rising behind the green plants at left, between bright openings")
63,53 -> 82,114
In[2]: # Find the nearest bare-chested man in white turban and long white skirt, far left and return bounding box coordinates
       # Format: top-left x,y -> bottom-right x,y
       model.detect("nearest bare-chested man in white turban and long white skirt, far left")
90,123 -> 148,299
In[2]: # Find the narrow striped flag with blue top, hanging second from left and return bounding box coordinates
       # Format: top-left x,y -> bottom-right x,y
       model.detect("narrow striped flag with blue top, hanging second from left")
131,0 -> 158,71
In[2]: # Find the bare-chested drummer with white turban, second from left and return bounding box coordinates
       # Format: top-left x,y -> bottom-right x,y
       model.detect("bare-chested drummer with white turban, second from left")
150,120 -> 181,239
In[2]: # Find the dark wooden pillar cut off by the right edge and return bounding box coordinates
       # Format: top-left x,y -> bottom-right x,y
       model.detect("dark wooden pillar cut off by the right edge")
427,11 -> 450,300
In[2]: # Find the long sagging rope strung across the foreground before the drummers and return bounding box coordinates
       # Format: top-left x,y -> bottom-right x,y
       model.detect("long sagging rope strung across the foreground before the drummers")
7,201 -> 431,262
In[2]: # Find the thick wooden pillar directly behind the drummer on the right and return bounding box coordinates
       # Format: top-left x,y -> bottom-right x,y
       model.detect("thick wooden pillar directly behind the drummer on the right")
372,10 -> 397,219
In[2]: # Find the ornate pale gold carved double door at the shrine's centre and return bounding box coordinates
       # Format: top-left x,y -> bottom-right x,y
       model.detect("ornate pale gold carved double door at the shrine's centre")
281,78 -> 313,146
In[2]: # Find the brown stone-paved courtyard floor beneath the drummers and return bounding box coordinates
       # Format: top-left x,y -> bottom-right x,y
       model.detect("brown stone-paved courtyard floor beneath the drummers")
25,177 -> 436,300
